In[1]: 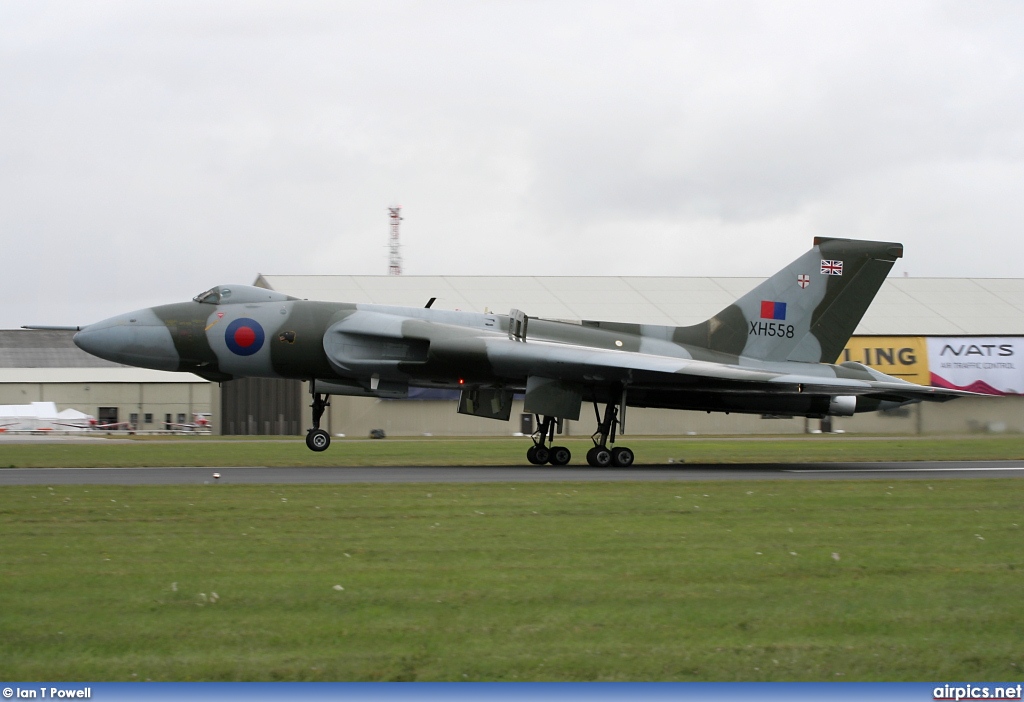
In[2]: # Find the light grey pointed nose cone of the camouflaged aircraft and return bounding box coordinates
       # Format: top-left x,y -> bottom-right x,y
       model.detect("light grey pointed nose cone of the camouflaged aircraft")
74,309 -> 179,370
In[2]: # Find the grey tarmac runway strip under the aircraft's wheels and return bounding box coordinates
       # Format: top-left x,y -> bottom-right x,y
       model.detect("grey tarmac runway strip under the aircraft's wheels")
0,460 -> 1024,486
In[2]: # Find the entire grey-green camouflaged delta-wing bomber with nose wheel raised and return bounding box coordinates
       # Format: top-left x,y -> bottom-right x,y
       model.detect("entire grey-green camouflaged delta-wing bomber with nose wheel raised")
56,237 -> 970,467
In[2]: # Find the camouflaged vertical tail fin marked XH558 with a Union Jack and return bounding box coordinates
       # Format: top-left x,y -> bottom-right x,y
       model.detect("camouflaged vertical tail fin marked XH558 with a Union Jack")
673,237 -> 903,363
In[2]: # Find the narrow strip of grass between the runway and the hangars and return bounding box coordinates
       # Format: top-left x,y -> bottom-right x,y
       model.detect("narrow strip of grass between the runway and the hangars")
0,436 -> 1024,468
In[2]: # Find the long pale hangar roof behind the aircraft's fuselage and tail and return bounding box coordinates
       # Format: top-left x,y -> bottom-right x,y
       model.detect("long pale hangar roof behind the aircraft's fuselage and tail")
255,275 -> 1024,336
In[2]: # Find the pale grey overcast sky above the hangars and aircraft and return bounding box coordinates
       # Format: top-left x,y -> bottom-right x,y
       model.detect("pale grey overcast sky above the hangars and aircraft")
0,0 -> 1024,328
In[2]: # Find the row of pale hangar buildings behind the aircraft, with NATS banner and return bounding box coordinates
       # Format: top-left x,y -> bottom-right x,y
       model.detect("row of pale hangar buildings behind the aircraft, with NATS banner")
6,275 -> 1024,436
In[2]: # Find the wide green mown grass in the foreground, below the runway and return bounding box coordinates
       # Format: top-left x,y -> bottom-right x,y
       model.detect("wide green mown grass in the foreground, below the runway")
0,478 -> 1024,681
